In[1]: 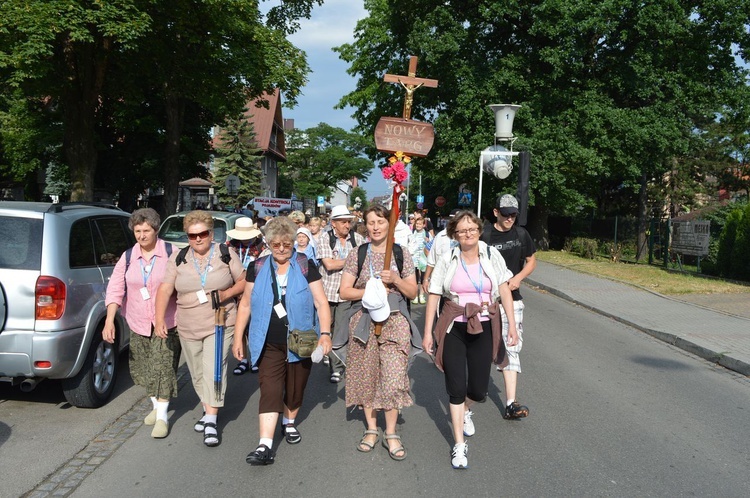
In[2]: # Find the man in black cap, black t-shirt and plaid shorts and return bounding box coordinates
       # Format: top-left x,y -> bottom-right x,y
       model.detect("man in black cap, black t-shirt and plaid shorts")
482,194 -> 536,420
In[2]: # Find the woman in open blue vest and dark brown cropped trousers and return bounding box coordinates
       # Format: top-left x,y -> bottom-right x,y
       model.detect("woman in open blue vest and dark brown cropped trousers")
232,216 -> 331,465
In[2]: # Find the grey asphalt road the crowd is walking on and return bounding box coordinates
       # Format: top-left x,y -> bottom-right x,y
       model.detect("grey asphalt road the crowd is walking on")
0,289 -> 750,497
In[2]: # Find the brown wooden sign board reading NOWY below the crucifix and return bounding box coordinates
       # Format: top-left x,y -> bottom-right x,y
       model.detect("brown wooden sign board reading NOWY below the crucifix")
375,117 -> 435,157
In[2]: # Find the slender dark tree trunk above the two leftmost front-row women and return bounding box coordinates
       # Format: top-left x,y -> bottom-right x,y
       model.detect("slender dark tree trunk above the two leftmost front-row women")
161,93 -> 185,219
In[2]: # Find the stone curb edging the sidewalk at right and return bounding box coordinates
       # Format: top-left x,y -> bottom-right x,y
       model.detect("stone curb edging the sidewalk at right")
525,277 -> 750,376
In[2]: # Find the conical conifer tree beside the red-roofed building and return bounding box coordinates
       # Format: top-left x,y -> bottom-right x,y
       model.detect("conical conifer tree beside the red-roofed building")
214,113 -> 262,205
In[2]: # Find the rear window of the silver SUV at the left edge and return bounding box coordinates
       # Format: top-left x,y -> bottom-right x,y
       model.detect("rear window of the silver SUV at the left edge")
0,216 -> 44,270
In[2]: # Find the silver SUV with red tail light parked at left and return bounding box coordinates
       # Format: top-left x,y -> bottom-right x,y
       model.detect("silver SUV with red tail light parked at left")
0,202 -> 135,408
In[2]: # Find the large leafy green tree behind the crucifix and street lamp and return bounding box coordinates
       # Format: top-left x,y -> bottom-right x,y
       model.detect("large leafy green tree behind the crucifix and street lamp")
337,0 -> 749,253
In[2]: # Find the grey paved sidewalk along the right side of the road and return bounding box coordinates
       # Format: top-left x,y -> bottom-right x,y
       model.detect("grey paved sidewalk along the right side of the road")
525,261 -> 750,376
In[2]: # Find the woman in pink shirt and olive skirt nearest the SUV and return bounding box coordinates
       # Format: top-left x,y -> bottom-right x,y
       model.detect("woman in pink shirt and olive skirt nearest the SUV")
102,208 -> 182,438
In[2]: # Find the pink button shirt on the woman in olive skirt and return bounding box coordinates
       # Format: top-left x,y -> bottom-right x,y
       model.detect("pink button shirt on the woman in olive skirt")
105,239 -> 179,337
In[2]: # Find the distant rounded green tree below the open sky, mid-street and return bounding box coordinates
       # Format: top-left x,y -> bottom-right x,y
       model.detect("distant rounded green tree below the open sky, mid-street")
280,123 -> 372,198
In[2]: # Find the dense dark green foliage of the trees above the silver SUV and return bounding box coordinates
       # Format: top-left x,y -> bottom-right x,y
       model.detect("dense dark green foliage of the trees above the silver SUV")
0,0 -> 321,212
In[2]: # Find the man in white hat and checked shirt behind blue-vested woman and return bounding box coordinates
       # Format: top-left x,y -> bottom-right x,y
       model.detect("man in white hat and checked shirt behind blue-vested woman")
318,204 -> 365,384
